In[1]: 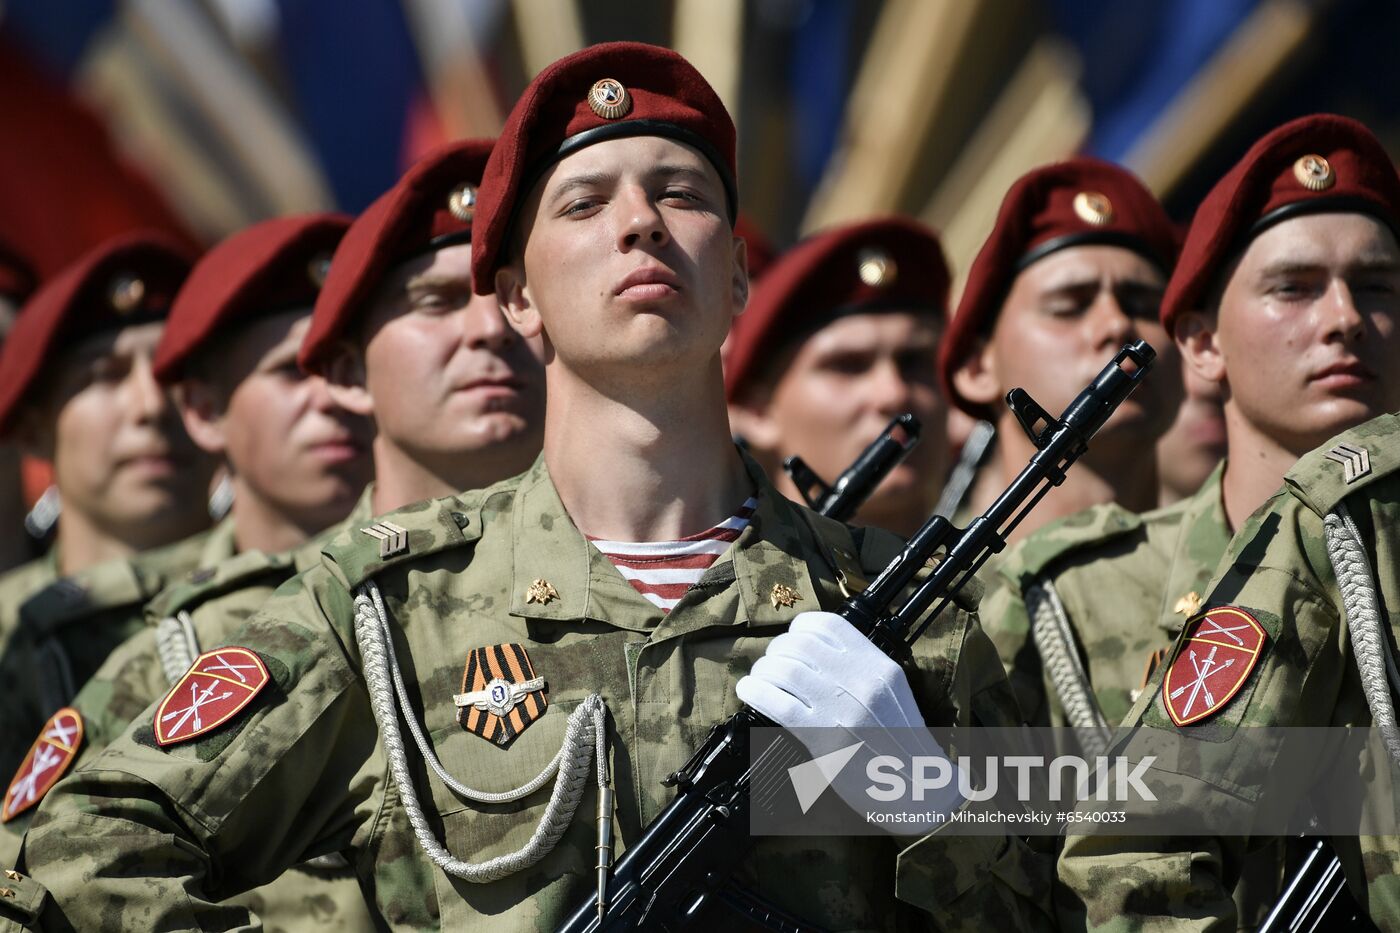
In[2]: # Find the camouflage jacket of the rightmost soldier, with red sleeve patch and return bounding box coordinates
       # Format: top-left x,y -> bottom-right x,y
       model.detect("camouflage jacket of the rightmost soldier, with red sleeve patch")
1058,415 -> 1400,929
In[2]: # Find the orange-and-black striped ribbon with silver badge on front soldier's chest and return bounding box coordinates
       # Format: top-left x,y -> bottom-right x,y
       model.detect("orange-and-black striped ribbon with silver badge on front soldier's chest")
452,644 -> 549,748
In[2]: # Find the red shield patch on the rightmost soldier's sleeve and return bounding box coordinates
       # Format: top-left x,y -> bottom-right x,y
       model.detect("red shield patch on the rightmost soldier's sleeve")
1162,605 -> 1268,726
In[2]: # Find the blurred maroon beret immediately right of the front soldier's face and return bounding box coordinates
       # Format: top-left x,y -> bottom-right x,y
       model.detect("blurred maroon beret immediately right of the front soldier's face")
724,217 -> 949,401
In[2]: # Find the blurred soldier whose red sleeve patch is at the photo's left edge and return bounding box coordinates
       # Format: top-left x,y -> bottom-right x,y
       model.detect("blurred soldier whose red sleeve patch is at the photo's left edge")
0,214 -> 372,913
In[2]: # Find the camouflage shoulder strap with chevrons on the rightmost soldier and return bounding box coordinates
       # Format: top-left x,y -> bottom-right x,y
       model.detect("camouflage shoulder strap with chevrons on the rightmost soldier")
1284,415 -> 1400,516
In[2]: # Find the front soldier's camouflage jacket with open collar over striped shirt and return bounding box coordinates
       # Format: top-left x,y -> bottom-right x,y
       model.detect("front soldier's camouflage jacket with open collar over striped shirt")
25,459 -> 1049,933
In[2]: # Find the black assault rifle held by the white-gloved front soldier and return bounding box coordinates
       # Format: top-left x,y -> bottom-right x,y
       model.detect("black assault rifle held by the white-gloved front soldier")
560,340 -> 1156,933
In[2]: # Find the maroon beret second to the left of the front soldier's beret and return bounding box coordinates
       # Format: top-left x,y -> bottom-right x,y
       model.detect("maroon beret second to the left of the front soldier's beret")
154,214 -> 350,382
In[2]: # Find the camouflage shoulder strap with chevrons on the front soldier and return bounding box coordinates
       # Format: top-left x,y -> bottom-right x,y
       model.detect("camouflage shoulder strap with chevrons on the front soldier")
321,492 -> 482,590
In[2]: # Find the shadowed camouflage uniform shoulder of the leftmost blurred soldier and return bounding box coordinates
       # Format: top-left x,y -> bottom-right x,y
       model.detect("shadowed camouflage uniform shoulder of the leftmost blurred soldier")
0,530 -> 210,776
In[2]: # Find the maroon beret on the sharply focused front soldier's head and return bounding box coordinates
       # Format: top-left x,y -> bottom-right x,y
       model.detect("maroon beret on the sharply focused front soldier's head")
472,42 -> 739,294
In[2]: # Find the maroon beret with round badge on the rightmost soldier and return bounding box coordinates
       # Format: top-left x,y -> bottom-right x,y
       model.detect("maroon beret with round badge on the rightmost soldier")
1162,113 -> 1400,332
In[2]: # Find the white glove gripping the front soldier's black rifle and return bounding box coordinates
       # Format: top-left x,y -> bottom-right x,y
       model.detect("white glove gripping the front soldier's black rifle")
735,612 -> 962,835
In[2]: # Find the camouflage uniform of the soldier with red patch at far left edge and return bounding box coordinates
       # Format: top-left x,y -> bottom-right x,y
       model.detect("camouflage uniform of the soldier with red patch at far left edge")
0,486 -> 375,930
